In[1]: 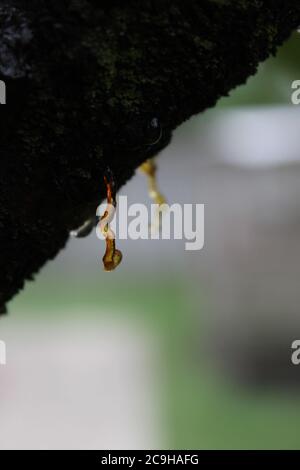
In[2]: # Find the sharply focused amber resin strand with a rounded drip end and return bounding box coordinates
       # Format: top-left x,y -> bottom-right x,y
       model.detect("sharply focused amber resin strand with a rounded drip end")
99,172 -> 123,272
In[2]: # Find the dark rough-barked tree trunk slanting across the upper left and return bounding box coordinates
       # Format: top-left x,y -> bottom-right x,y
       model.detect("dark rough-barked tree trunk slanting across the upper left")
0,0 -> 300,311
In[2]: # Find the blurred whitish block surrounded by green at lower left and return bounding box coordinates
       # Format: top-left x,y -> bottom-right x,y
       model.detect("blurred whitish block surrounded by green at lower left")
0,311 -> 162,450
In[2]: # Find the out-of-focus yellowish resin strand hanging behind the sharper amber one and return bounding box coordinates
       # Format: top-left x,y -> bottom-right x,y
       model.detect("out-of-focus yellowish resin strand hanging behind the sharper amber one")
139,159 -> 166,233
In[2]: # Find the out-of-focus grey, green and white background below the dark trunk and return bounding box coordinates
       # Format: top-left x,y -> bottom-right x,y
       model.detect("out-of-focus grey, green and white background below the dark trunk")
0,33 -> 300,449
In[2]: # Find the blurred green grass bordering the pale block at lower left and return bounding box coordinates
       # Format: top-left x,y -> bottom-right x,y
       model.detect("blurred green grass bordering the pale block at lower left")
11,278 -> 300,449
